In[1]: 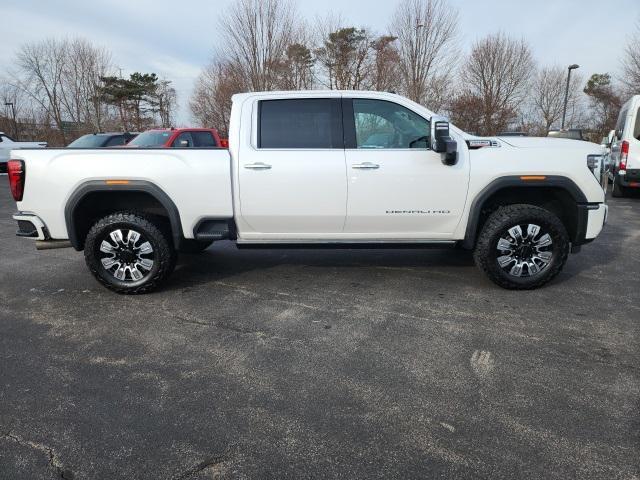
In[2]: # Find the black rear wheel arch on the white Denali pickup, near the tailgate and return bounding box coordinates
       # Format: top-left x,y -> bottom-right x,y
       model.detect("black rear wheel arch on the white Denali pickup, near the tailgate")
64,180 -> 182,251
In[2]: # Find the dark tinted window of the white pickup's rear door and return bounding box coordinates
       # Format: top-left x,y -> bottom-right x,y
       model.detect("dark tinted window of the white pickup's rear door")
258,98 -> 344,148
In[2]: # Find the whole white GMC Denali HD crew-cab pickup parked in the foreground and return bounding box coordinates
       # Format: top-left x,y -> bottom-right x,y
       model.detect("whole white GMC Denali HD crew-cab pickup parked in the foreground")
9,91 -> 607,293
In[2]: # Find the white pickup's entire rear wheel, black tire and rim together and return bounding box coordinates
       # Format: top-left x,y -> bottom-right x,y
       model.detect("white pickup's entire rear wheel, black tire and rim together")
84,212 -> 176,294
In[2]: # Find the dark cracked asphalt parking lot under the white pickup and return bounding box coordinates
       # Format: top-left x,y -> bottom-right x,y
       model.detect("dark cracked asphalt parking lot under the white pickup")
0,177 -> 640,480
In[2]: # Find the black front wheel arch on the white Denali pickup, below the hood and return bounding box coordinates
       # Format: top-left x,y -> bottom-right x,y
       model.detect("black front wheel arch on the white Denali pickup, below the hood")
462,176 -> 588,249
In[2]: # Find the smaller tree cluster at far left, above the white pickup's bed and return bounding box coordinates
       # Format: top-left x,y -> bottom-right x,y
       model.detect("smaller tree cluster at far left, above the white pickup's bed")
0,38 -> 176,146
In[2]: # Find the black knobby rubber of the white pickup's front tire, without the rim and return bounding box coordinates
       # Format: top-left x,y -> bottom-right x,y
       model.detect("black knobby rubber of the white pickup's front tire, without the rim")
473,204 -> 570,290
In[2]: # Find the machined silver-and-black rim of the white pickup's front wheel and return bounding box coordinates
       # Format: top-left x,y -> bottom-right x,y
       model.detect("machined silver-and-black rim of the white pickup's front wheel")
497,223 -> 553,277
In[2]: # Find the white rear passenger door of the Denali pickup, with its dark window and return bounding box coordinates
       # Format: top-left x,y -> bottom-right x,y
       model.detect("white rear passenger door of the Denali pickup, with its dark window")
237,96 -> 347,240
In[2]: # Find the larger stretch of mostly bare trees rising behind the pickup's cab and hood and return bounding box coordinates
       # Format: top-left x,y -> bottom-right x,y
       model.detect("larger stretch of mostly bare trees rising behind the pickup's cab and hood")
190,0 -> 640,140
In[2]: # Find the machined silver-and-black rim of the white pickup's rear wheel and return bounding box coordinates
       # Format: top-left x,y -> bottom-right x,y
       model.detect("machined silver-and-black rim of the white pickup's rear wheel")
99,229 -> 154,282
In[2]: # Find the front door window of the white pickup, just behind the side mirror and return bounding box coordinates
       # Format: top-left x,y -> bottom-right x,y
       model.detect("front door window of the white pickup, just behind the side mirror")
353,98 -> 429,148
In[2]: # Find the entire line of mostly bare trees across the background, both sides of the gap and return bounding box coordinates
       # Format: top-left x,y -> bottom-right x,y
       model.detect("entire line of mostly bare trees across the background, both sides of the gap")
0,0 -> 640,145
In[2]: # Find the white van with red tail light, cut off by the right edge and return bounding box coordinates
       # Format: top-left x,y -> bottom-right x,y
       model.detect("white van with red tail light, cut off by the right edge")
611,95 -> 640,197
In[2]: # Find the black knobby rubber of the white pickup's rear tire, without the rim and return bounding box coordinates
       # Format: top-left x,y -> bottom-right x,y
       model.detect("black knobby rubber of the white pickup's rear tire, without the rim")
84,212 -> 177,294
